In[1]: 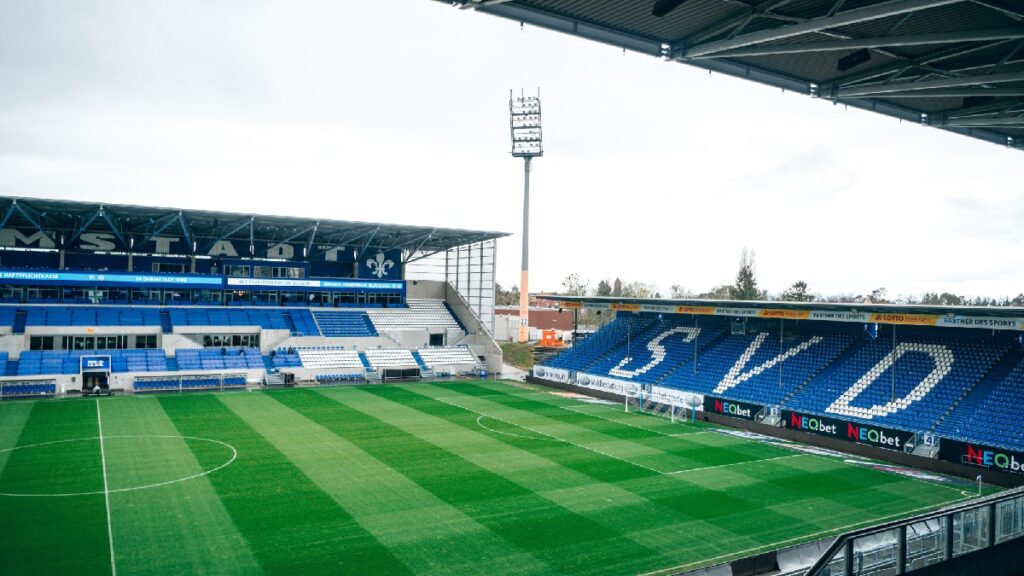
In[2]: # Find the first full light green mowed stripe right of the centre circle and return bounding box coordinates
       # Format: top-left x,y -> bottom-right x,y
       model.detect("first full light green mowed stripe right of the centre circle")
221,390 -> 553,576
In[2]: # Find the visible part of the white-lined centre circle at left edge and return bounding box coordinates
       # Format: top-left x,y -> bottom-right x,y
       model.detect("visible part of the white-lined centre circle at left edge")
0,435 -> 238,498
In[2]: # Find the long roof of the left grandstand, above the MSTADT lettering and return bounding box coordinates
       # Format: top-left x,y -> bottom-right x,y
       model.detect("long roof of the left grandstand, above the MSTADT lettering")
0,197 -> 509,255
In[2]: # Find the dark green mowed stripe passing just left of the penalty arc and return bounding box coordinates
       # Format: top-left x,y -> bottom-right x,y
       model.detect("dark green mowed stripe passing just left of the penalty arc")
274,390 -> 679,574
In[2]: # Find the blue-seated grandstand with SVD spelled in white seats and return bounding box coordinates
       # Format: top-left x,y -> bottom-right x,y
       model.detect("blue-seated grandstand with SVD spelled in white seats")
540,296 -> 1024,457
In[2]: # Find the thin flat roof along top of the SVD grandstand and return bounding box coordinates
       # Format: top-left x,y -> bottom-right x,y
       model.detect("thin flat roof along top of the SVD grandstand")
538,294 -> 1024,319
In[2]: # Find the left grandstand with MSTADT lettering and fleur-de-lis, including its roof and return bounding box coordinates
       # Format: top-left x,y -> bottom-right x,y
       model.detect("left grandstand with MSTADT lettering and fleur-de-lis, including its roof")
0,198 -> 503,394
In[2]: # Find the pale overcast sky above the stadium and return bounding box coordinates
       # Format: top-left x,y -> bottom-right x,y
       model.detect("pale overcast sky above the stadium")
0,0 -> 1024,296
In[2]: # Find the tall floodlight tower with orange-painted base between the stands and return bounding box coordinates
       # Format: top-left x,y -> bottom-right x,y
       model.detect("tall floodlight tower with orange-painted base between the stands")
509,89 -> 544,342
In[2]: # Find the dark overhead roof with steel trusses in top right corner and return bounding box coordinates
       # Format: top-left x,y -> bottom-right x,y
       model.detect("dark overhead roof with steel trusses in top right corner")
441,0 -> 1024,149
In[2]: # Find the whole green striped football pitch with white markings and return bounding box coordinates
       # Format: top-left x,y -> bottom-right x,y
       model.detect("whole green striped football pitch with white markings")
0,381 -> 983,575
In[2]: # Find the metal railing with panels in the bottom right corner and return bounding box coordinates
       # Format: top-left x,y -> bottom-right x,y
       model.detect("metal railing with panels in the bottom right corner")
805,488 -> 1024,576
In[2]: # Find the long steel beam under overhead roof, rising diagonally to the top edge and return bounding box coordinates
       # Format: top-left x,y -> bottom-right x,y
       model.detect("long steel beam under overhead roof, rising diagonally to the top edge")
682,0 -> 963,58
